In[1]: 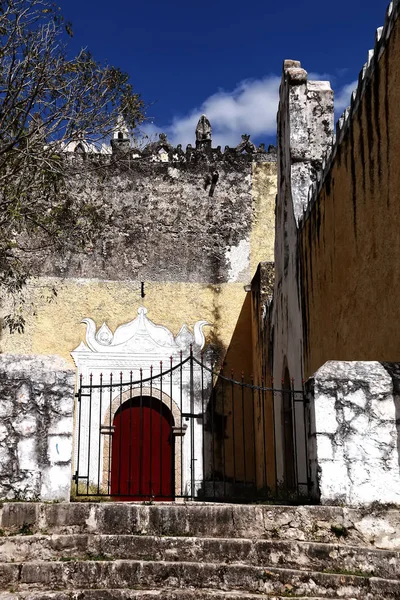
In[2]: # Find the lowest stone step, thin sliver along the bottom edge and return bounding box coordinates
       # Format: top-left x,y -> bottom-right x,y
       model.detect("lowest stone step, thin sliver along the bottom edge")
0,589 -> 355,600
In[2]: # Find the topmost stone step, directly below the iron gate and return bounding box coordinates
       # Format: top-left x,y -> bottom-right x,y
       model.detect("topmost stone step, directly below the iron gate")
0,502 -> 400,550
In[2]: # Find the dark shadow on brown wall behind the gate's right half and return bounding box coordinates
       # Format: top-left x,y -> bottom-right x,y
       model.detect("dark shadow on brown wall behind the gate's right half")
207,294 -> 275,498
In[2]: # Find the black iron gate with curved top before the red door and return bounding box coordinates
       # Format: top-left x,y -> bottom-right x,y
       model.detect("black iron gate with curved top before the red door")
73,352 -> 311,502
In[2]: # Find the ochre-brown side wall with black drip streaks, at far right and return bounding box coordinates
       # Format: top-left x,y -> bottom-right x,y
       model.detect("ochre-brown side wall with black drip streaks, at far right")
299,1 -> 400,377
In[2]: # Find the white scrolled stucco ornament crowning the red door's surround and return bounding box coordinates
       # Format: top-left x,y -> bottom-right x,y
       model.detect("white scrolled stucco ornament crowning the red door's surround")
74,306 -> 210,354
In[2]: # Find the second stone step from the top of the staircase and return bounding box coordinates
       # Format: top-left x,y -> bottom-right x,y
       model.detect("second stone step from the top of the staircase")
0,534 -> 400,579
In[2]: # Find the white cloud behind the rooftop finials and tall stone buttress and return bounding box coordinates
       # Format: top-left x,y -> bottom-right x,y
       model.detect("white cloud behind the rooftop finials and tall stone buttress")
142,73 -> 356,148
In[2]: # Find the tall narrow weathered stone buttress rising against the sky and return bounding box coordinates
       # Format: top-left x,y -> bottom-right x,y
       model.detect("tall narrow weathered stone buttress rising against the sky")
271,60 -> 333,390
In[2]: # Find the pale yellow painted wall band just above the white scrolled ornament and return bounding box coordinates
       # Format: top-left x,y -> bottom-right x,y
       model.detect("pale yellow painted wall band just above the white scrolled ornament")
2,279 -> 246,362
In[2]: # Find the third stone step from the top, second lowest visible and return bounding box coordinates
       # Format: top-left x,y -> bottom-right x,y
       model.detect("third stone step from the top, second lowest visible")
0,560 -> 400,600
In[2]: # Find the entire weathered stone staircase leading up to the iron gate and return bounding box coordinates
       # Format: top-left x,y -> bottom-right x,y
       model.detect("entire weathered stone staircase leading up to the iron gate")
0,502 -> 400,600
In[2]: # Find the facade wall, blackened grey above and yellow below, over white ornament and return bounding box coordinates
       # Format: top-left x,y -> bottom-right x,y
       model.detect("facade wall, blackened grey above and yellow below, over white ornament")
1,147 -> 276,372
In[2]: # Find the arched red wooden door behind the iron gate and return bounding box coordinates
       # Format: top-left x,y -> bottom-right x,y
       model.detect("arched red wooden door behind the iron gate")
111,398 -> 174,500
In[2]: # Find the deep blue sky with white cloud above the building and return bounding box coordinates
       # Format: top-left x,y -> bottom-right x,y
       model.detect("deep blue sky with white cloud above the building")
58,0 -> 388,146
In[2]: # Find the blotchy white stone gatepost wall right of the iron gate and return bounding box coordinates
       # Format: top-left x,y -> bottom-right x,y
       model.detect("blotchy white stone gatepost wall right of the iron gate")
307,361 -> 400,505
